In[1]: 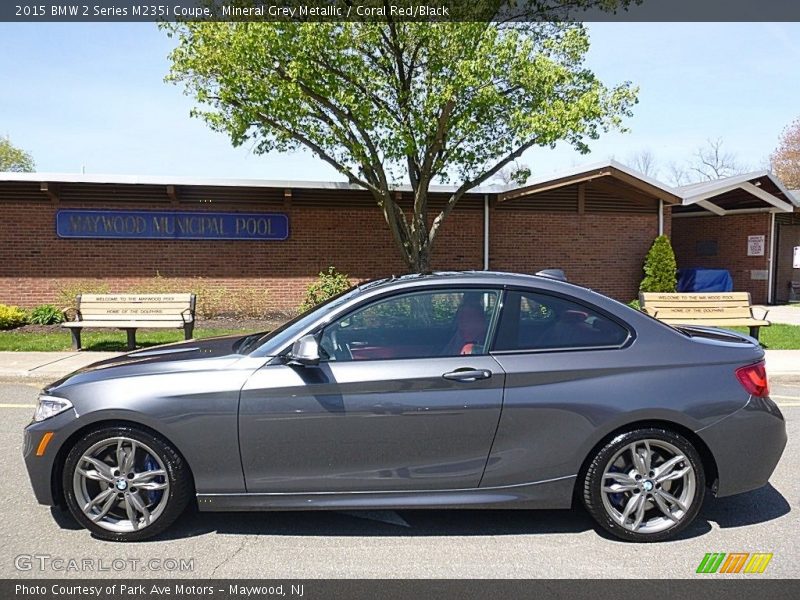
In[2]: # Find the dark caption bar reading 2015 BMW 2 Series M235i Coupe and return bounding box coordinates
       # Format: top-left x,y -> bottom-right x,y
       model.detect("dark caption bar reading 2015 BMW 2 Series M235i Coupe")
0,0 -> 800,23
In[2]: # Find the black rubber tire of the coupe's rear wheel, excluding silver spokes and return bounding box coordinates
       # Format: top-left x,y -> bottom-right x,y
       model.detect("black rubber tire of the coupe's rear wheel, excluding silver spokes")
582,427 -> 706,542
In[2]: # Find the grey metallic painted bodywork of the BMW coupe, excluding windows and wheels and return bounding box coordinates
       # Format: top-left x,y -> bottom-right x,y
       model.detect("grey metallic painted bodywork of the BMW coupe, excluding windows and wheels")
24,273 -> 786,510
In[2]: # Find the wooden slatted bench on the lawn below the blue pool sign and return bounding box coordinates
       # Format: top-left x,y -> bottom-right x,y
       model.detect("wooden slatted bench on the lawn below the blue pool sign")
62,294 -> 195,350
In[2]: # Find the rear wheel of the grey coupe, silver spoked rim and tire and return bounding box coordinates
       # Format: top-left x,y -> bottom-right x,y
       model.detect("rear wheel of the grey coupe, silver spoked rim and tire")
583,428 -> 705,542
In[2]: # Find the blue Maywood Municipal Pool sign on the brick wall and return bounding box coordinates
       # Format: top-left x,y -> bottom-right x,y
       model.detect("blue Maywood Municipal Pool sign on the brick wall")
56,209 -> 289,240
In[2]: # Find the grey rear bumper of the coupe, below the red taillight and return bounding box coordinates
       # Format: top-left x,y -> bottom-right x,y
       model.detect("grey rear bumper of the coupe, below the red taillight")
696,397 -> 786,497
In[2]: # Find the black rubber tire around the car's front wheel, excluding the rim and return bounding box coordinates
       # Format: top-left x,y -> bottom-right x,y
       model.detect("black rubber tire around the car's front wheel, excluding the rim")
62,425 -> 194,542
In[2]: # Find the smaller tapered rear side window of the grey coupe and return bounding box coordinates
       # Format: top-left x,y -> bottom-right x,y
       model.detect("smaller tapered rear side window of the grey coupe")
494,291 -> 628,350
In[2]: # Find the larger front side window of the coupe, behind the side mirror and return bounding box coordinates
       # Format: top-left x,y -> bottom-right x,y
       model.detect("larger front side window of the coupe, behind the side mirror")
320,289 -> 499,361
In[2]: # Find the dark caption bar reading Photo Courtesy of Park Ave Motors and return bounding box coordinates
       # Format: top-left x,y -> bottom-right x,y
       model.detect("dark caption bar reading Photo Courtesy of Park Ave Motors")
0,575 -> 800,600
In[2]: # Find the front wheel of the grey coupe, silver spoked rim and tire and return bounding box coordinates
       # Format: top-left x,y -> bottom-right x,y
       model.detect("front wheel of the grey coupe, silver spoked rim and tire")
63,426 -> 192,542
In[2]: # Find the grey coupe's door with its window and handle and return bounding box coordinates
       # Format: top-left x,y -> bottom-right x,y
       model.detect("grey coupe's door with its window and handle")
239,289 -> 505,493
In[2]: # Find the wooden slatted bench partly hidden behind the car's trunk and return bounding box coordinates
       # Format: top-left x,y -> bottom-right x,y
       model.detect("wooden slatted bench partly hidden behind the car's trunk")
639,292 -> 770,339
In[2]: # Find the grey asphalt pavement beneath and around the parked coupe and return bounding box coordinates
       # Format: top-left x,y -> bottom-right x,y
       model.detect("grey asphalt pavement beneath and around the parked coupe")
0,379 -> 800,578
